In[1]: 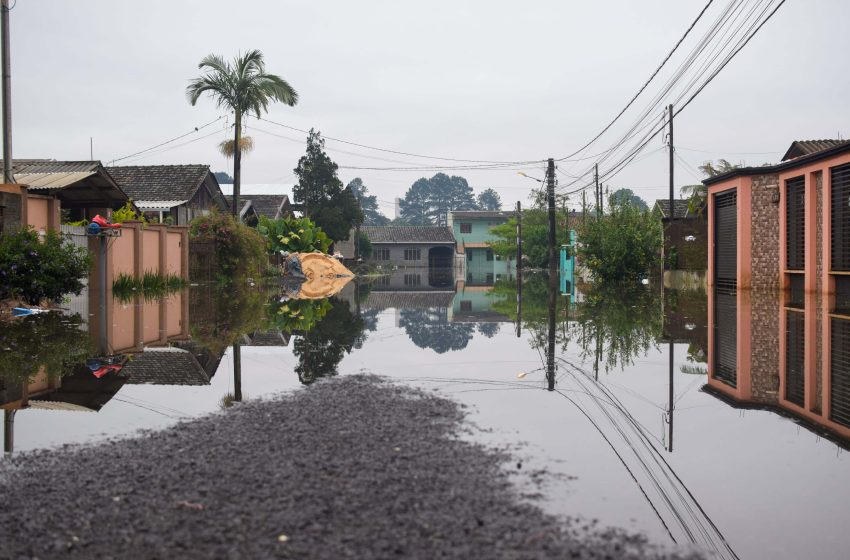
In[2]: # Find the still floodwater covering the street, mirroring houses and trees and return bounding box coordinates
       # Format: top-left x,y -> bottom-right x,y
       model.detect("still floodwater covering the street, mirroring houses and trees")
0,270 -> 850,559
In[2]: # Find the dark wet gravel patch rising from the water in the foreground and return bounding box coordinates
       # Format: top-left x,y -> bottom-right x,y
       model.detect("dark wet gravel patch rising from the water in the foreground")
0,375 -> 704,559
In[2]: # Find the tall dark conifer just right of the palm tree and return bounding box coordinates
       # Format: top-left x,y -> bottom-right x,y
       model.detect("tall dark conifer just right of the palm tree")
292,129 -> 363,241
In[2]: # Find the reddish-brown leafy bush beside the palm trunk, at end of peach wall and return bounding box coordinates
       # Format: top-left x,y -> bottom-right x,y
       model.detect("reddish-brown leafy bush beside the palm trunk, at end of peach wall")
189,212 -> 268,279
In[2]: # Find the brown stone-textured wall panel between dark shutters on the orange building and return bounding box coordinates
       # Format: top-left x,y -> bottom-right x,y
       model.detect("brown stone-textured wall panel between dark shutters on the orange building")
750,175 -> 780,290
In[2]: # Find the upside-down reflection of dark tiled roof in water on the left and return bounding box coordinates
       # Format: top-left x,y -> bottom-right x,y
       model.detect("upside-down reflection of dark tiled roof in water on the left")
123,347 -> 210,385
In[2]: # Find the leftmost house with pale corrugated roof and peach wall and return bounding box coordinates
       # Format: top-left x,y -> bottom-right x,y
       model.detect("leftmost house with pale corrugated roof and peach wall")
0,159 -> 128,232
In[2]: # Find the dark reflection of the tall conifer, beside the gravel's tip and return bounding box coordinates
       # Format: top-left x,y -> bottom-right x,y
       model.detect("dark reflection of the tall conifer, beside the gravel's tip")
292,297 -> 364,385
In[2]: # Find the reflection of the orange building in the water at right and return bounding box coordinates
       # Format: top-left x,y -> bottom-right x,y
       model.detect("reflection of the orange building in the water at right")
704,289 -> 850,448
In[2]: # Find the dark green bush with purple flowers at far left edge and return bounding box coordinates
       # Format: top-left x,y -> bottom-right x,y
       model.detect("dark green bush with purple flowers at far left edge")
0,228 -> 91,305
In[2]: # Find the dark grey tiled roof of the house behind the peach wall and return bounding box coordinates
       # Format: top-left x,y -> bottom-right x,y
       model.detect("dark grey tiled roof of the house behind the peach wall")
106,165 -> 210,201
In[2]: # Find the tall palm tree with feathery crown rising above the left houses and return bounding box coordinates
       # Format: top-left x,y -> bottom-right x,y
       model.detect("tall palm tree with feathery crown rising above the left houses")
186,49 -> 298,216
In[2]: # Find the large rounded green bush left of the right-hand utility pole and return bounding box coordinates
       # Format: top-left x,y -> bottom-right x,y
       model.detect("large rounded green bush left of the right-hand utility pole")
578,204 -> 662,282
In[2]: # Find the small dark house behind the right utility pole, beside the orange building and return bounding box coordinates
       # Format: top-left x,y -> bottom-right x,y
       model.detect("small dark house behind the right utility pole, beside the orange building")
653,199 -> 708,271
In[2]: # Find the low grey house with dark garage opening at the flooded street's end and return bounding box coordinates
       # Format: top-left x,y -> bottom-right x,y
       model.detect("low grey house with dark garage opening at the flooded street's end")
336,226 -> 455,268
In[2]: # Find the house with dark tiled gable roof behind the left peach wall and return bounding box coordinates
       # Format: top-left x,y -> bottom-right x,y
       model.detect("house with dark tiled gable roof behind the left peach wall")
107,165 -> 228,225
